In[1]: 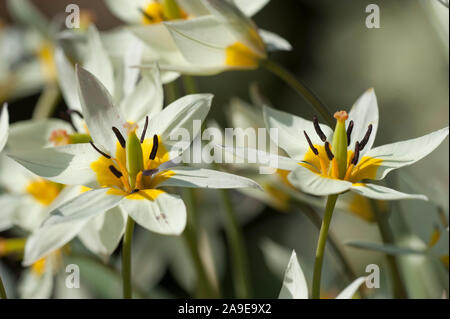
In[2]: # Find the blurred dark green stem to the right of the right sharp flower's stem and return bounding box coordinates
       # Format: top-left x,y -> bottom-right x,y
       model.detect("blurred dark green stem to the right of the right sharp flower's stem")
370,200 -> 408,299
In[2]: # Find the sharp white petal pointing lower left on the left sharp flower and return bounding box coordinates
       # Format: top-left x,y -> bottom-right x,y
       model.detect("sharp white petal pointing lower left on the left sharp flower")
42,188 -> 124,226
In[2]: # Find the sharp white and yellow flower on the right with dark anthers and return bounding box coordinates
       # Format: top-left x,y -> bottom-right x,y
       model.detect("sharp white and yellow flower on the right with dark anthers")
230,89 -> 448,200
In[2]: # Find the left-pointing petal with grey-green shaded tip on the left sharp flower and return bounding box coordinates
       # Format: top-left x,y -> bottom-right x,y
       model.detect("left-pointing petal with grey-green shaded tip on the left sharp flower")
9,144 -> 102,187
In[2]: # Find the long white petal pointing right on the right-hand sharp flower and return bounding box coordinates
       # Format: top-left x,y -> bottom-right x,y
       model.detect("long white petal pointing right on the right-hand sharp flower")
366,127 -> 448,179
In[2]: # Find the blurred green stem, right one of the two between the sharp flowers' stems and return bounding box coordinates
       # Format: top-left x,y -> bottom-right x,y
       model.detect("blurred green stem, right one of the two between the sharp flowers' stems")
220,189 -> 251,298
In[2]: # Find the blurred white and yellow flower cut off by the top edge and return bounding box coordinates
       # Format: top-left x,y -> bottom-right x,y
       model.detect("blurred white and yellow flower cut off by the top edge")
107,0 -> 291,75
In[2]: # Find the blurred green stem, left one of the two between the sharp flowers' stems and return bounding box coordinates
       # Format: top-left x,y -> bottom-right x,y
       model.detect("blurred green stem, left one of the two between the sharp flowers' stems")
183,188 -> 219,298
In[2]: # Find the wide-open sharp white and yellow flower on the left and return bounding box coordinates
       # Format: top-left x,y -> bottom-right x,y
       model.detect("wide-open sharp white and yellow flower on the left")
10,68 -> 257,264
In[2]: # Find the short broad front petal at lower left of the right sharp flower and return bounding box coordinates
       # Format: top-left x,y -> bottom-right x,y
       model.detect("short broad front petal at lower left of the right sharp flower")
288,166 -> 352,196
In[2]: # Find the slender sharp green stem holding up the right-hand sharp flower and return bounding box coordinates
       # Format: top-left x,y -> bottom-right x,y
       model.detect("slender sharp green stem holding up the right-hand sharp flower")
312,195 -> 339,299
